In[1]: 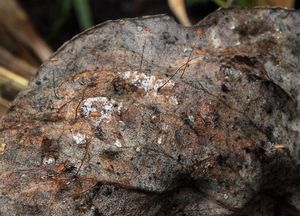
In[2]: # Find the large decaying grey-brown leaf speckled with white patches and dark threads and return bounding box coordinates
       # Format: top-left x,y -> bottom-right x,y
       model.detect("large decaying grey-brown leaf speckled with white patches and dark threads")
0,9 -> 300,215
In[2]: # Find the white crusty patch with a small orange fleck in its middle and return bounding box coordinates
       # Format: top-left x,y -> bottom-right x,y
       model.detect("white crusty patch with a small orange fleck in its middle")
82,97 -> 123,123
